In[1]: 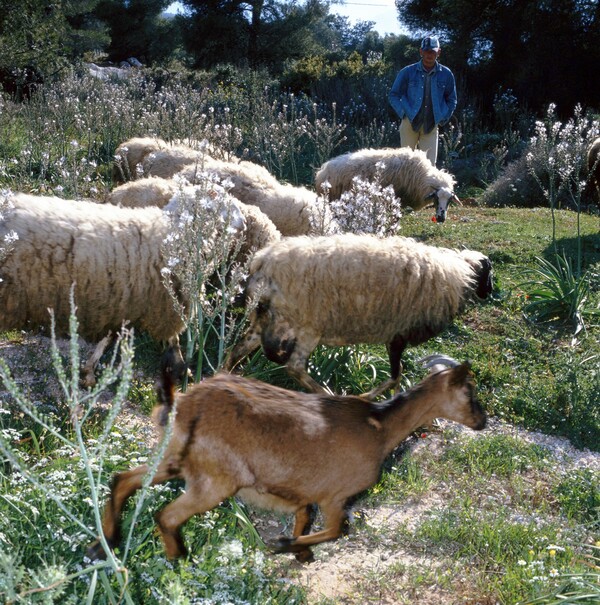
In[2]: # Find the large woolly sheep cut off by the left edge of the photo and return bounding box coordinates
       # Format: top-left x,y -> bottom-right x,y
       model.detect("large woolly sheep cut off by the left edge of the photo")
0,193 -> 243,385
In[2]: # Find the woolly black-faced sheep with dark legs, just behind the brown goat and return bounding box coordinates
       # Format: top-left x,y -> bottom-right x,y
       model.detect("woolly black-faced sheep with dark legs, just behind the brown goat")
225,233 -> 492,398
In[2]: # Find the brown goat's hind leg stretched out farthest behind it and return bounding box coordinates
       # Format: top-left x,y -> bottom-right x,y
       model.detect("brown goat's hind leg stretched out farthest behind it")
87,464 -> 177,560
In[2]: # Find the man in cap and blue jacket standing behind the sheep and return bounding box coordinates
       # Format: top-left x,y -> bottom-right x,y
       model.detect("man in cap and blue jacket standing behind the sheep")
389,36 -> 456,166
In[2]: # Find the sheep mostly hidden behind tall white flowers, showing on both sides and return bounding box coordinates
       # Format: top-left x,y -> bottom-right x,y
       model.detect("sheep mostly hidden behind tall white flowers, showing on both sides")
107,177 -> 281,262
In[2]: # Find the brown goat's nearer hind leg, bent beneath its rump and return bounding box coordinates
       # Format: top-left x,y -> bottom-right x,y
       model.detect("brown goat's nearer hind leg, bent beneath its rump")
154,480 -> 238,559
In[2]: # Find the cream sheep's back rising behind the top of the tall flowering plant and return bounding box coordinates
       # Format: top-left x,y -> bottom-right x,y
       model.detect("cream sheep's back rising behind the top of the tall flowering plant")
180,156 -> 336,237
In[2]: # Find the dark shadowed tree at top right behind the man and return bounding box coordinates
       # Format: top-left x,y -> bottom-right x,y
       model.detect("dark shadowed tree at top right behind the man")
396,0 -> 600,114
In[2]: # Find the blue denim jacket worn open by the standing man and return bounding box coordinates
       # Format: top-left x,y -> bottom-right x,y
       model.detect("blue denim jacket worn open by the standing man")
388,61 -> 456,125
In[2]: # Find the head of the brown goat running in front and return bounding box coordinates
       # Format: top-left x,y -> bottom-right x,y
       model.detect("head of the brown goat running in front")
420,354 -> 487,431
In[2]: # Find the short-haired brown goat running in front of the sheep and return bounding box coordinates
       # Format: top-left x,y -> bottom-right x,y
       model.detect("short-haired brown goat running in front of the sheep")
88,358 -> 486,562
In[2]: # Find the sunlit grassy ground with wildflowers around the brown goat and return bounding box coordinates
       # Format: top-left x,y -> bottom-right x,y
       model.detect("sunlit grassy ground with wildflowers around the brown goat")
0,199 -> 600,605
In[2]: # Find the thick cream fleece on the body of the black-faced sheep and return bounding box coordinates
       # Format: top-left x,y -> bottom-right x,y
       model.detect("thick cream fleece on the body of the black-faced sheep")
250,234 -> 485,345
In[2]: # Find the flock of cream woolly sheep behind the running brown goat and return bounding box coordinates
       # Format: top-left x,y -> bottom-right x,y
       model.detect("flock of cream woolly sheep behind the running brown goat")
0,137 -> 480,386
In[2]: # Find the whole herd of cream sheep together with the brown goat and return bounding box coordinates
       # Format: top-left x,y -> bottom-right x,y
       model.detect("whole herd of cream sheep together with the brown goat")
0,138 -> 492,560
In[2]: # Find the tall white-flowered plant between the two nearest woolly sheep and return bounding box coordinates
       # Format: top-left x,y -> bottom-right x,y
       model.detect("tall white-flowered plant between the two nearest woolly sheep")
162,175 -> 252,388
